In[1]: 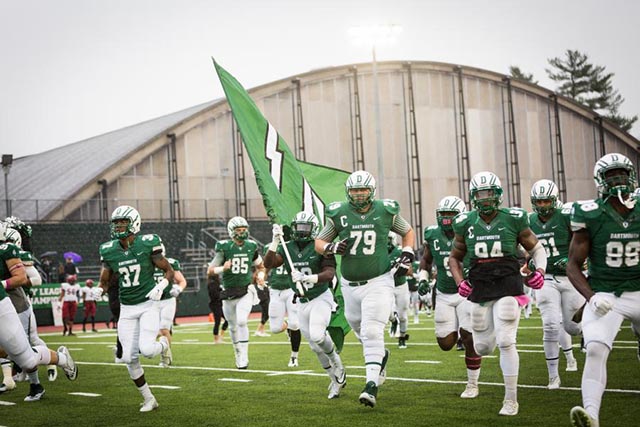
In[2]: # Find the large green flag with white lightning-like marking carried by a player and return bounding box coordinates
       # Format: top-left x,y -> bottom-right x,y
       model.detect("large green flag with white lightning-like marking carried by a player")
213,60 -> 350,350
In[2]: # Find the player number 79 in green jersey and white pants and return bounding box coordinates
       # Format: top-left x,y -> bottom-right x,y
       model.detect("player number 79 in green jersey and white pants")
315,170 -> 415,407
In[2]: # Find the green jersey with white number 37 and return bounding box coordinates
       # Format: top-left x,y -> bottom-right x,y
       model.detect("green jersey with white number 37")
100,234 -> 162,305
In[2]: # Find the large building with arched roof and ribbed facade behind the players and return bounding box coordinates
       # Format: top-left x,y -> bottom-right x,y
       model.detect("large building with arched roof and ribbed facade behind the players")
0,61 -> 639,322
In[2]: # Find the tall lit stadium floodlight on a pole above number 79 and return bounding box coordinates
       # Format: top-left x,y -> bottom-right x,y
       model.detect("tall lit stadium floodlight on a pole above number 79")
349,24 -> 402,198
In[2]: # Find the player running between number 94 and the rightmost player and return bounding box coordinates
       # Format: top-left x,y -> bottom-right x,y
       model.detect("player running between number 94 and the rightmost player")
529,179 -> 585,390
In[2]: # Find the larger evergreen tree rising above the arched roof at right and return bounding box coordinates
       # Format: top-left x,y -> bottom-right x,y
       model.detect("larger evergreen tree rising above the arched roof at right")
545,49 -> 638,131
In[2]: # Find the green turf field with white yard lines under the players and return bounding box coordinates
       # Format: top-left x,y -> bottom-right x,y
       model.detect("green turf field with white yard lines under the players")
0,313 -> 640,427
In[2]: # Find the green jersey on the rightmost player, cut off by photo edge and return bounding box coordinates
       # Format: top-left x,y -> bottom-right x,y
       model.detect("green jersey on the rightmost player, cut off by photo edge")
571,199 -> 640,296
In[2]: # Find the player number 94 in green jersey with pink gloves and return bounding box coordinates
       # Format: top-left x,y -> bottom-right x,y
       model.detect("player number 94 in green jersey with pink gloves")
449,172 -> 547,416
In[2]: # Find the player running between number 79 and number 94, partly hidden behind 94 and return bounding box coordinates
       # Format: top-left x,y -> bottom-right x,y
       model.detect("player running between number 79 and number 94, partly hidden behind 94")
418,196 -> 482,399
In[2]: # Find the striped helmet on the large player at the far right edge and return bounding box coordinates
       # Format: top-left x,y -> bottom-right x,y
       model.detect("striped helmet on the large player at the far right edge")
593,153 -> 638,203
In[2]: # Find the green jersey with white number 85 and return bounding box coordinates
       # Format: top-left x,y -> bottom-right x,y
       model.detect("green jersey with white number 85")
215,239 -> 259,289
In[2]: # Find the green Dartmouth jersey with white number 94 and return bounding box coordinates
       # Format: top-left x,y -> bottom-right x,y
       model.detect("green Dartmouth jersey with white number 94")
453,208 -> 529,267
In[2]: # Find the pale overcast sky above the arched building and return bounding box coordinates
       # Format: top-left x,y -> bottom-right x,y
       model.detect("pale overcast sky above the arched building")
0,0 -> 640,157
